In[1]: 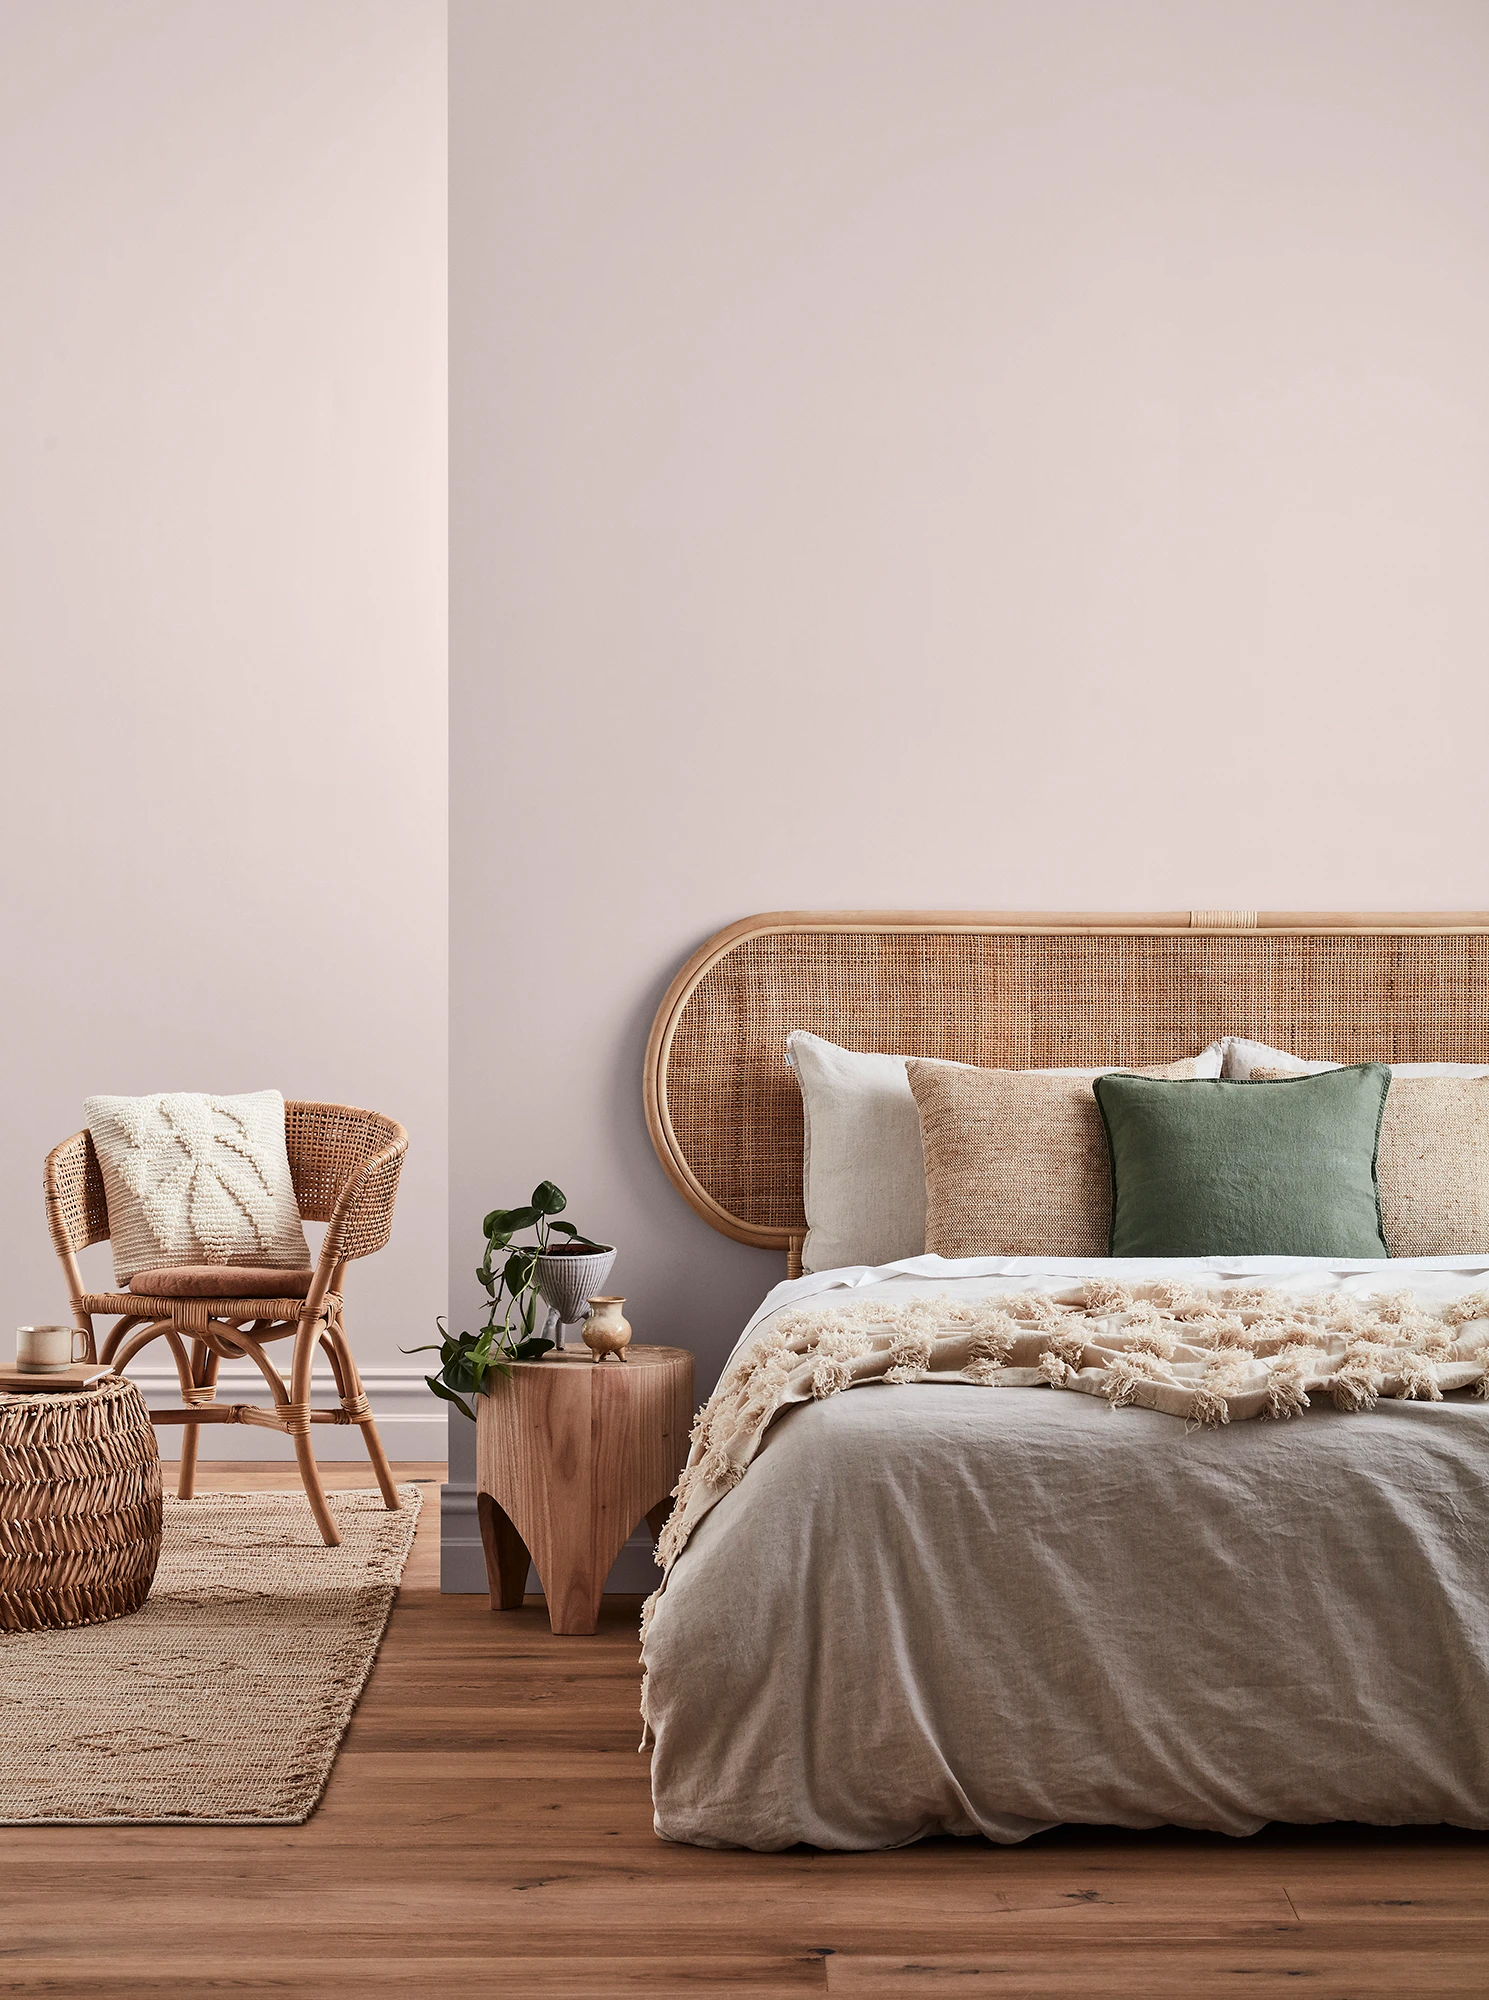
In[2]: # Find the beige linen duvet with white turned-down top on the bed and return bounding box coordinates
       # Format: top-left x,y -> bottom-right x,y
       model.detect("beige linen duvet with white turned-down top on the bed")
642,1258 -> 1489,1848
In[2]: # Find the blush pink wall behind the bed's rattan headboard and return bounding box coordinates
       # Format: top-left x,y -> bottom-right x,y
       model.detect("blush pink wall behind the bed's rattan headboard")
450,0 -> 1489,1528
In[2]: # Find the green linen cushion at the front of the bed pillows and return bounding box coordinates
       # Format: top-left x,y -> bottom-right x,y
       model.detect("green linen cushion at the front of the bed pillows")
1091,1062 -> 1391,1258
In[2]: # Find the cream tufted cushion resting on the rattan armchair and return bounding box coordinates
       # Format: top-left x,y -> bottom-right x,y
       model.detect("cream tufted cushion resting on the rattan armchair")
82,1090 -> 312,1284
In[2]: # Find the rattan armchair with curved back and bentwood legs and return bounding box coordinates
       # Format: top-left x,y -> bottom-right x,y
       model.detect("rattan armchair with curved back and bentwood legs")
46,1102 -> 408,1546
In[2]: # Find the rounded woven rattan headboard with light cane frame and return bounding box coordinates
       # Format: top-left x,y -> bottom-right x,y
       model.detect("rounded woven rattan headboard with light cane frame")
646,910 -> 1489,1252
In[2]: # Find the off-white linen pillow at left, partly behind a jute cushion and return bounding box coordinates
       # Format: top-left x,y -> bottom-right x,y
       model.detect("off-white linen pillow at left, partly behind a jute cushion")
787,1028 -> 1221,1270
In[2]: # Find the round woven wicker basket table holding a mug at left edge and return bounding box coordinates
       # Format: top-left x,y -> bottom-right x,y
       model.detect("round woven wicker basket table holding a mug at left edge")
0,1376 -> 160,1632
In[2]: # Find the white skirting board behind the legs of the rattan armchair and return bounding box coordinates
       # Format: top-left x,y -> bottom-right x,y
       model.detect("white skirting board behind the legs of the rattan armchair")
126,1356 -> 446,1464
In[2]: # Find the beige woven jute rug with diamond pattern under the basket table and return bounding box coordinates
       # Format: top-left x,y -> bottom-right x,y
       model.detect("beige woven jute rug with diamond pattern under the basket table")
0,1486 -> 420,1826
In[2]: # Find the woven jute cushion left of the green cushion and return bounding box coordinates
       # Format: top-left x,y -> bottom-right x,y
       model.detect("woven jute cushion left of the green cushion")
907,1058 -> 1195,1256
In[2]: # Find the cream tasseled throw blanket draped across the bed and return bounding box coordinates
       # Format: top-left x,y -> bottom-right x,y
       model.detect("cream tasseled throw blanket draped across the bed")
640,1280 -> 1489,1636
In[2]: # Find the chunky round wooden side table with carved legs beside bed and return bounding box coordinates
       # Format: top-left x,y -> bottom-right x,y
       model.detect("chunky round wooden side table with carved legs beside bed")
476,1346 -> 692,1634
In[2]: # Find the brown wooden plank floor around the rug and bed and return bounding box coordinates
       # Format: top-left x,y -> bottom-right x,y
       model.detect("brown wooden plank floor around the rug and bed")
0,1466 -> 1489,2000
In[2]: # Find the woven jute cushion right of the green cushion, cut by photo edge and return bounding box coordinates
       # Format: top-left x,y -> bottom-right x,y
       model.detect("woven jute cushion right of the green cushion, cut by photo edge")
1251,1068 -> 1489,1256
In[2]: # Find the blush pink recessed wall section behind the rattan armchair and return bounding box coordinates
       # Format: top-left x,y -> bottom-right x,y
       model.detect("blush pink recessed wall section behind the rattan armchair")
0,0 -> 446,1456
